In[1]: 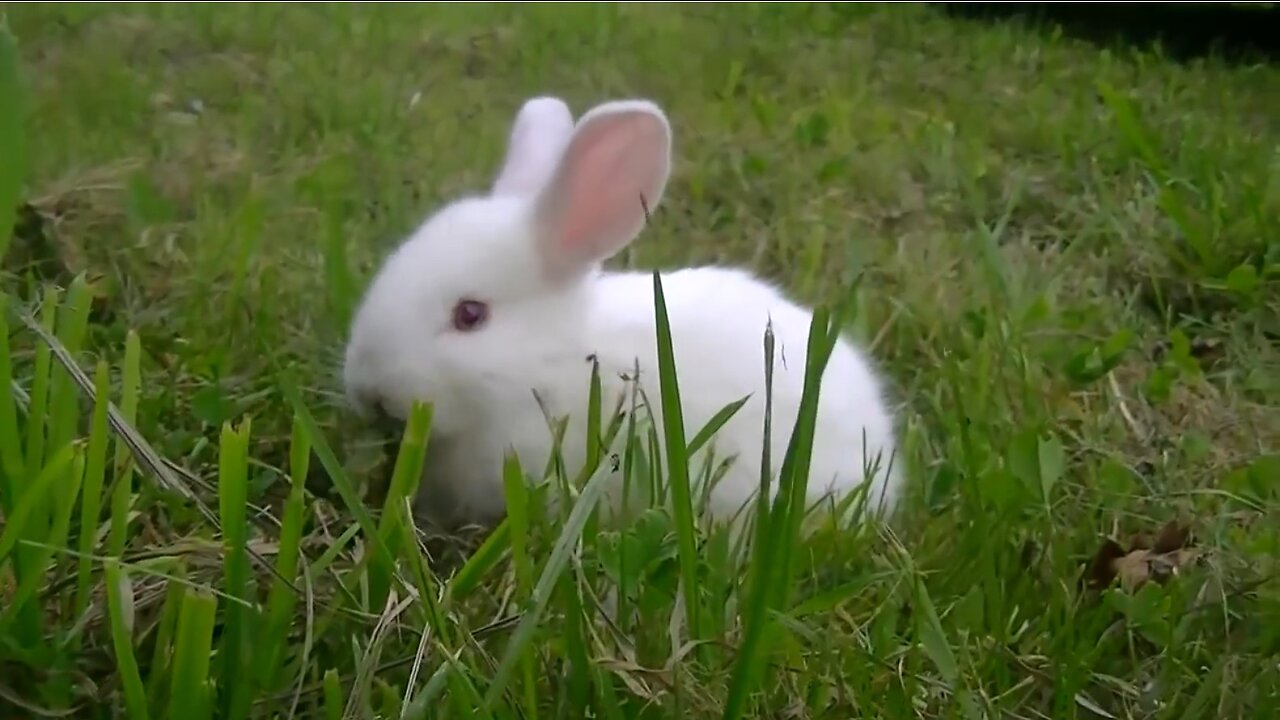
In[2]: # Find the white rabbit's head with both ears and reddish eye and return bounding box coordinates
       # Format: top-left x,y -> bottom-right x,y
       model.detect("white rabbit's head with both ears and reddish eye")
344,97 -> 671,437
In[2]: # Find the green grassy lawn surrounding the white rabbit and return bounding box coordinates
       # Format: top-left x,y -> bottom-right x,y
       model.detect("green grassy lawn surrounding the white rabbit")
0,4 -> 1280,719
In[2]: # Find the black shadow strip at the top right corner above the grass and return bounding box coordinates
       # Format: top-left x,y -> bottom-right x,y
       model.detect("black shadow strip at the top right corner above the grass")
933,3 -> 1280,64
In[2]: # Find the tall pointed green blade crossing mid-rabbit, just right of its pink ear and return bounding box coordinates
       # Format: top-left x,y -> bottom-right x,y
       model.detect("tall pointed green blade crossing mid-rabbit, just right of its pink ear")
653,272 -> 703,641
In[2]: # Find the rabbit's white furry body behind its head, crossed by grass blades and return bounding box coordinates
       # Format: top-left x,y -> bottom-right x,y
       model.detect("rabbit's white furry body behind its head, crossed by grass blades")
588,268 -> 896,515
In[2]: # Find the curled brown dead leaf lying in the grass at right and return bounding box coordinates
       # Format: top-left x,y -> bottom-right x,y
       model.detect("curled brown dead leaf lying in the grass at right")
1084,520 -> 1199,592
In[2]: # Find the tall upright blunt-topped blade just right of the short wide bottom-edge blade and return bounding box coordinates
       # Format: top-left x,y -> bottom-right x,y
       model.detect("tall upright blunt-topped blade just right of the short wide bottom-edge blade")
218,419 -> 253,720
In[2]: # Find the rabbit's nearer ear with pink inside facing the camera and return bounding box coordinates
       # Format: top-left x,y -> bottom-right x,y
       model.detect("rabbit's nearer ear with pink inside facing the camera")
536,100 -> 671,277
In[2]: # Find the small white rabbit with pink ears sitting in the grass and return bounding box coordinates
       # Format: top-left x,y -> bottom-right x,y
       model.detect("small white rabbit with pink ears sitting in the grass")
344,97 -> 902,524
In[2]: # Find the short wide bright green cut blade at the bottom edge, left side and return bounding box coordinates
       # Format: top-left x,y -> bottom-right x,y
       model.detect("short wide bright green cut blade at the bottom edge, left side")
166,588 -> 218,720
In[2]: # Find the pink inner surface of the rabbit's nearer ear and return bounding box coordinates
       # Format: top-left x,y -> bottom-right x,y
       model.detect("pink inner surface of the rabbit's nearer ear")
552,113 -> 666,263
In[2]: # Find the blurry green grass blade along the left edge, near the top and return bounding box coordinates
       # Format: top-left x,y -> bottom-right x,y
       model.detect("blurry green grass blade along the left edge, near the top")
0,17 -> 27,260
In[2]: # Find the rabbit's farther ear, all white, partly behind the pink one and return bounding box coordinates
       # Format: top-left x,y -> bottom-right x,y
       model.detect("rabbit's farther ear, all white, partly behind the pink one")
493,97 -> 573,195
